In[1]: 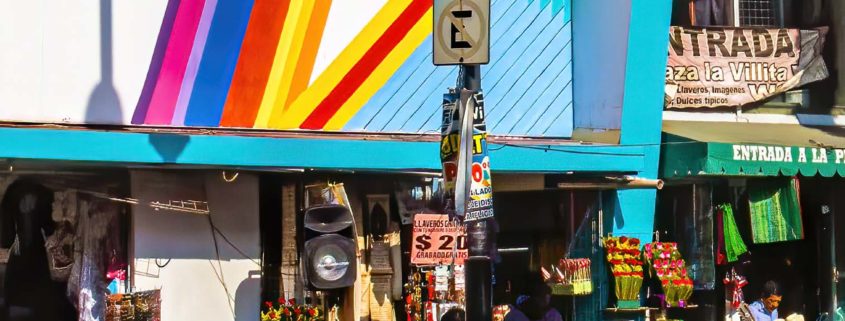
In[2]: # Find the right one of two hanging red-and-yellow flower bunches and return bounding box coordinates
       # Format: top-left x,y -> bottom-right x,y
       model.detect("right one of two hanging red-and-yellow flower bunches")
644,242 -> 693,307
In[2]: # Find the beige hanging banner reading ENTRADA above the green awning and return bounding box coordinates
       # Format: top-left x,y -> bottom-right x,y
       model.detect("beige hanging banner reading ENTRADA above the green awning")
666,27 -> 828,108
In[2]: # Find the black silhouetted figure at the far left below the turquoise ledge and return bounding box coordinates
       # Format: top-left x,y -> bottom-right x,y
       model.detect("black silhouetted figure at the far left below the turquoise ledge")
0,180 -> 73,320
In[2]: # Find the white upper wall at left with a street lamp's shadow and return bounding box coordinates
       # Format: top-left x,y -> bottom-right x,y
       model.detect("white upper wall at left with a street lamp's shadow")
0,0 -> 167,124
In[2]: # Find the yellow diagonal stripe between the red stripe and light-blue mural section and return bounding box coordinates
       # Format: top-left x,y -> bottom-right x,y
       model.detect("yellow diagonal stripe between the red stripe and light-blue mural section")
323,9 -> 433,130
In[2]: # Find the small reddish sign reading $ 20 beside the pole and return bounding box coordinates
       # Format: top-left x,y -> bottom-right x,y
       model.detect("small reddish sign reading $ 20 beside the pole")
411,214 -> 467,265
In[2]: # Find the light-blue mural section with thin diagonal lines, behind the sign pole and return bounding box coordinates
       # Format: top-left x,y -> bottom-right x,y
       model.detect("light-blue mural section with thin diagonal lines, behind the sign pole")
344,0 -> 572,136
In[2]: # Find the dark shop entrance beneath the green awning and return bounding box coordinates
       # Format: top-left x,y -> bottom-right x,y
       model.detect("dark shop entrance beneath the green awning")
657,177 -> 845,321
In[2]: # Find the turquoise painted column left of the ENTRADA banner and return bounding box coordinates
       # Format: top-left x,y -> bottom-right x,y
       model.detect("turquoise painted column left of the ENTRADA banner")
611,0 -> 672,242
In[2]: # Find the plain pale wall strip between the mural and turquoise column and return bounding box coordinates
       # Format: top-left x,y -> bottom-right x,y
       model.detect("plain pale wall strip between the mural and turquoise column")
572,0 -> 631,129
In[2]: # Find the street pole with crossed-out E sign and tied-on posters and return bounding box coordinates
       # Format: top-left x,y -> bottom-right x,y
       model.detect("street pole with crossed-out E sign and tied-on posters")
432,0 -> 496,321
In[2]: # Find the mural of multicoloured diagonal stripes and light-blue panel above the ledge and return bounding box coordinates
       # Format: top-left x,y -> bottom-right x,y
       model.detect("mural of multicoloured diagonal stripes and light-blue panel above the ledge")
132,0 -> 571,136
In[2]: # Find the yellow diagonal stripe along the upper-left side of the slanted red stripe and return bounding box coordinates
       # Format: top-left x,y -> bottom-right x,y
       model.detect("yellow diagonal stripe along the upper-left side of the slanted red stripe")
268,0 -> 411,129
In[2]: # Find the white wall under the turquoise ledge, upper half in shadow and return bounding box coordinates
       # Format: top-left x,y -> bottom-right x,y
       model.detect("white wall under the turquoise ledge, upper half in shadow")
131,171 -> 261,321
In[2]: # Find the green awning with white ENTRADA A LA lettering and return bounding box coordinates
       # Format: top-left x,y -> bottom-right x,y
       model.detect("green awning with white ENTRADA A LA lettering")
660,121 -> 845,178
